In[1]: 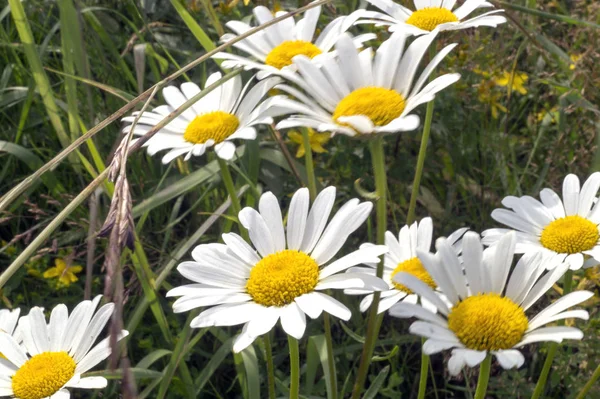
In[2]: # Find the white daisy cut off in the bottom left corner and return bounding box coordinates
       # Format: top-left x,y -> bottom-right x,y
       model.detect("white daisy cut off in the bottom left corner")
0,296 -> 127,399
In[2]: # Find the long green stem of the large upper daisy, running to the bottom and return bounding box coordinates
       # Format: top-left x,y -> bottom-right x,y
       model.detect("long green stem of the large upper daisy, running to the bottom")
352,137 -> 387,399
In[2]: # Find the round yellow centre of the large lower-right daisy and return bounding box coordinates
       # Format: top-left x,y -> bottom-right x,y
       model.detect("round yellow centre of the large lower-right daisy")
448,293 -> 529,351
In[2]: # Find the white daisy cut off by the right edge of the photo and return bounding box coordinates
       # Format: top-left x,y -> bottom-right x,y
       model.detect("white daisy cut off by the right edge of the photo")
482,172 -> 600,270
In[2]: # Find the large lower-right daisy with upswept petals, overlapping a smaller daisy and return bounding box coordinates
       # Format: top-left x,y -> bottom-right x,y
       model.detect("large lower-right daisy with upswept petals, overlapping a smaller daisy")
390,232 -> 593,375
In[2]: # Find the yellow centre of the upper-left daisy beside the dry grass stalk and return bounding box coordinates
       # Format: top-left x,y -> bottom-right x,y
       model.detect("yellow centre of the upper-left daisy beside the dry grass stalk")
183,111 -> 240,144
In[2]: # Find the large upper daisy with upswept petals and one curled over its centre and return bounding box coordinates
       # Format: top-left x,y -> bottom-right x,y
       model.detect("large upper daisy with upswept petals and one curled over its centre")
276,32 -> 460,136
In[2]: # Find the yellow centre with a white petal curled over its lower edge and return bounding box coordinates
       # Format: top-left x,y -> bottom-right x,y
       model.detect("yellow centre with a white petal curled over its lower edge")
333,87 -> 405,126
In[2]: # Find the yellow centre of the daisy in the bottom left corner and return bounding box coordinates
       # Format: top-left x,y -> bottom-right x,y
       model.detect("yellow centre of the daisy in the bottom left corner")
12,352 -> 76,399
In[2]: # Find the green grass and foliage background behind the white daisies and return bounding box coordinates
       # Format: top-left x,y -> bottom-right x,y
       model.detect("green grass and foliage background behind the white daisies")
0,0 -> 600,398
